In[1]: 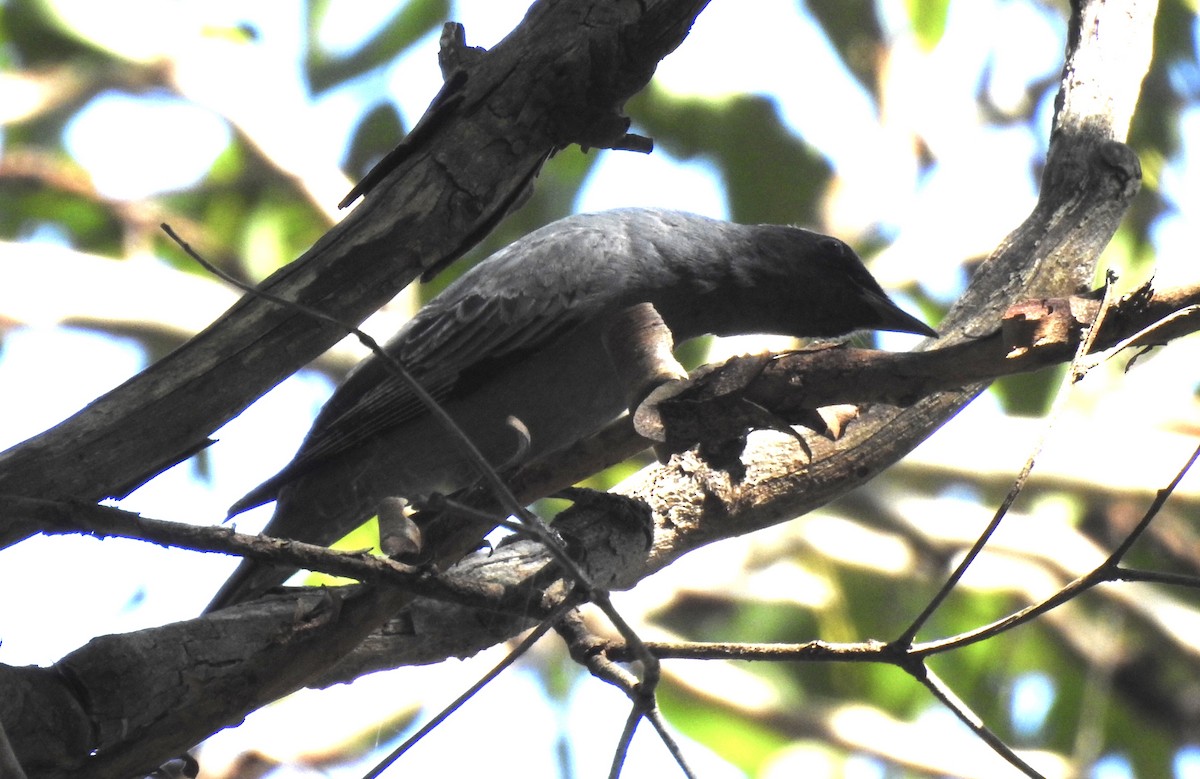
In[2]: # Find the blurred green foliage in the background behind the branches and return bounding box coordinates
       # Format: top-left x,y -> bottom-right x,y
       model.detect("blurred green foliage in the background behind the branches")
0,0 -> 1200,777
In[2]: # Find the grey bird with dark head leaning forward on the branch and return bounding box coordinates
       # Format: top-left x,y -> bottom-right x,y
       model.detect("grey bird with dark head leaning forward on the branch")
209,209 -> 937,611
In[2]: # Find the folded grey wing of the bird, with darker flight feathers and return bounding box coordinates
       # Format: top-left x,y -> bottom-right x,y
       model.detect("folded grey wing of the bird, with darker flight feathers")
229,212 -> 646,516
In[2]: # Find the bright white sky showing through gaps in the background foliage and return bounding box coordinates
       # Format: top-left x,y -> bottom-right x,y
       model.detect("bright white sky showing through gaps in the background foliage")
0,0 -> 1200,777
